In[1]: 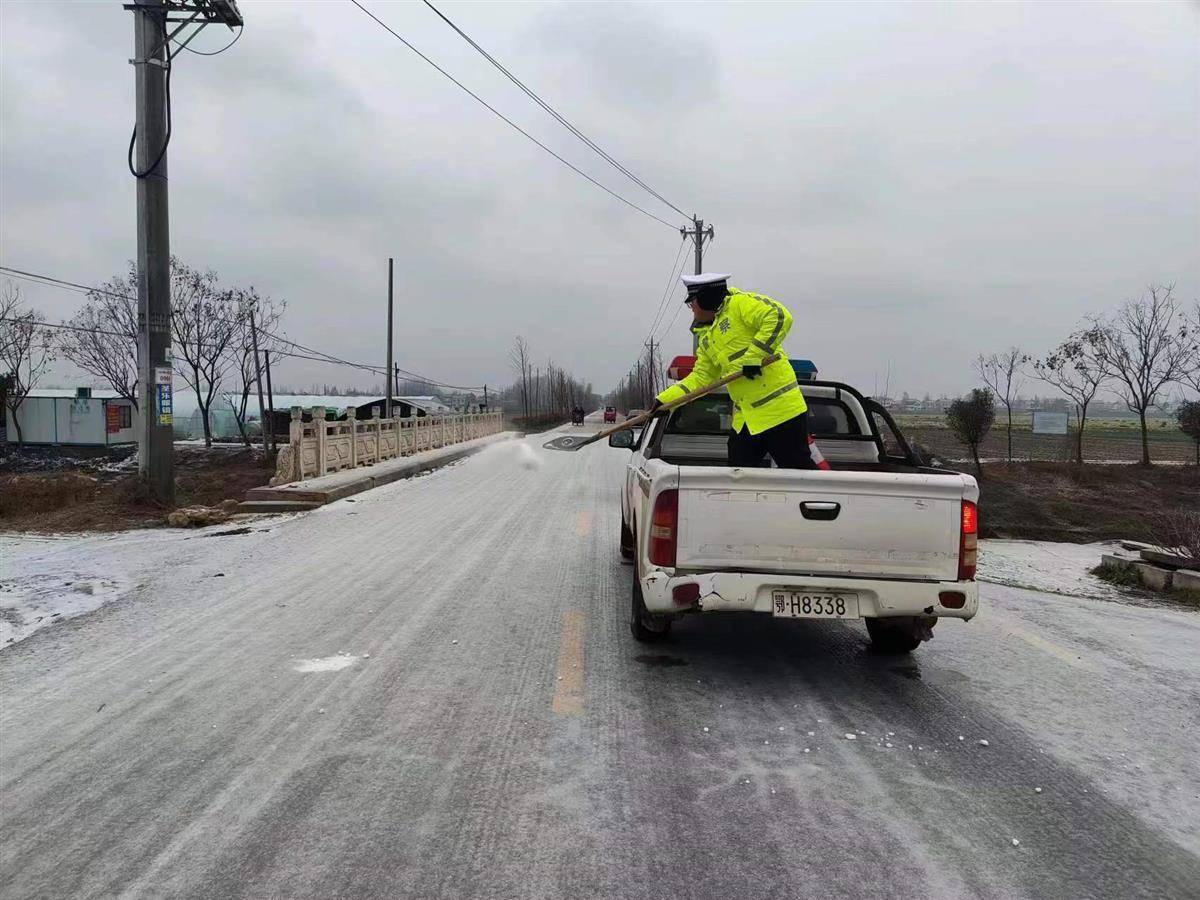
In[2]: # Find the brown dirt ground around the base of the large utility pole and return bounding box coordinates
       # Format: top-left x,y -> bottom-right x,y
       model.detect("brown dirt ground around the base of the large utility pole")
0,446 -> 271,532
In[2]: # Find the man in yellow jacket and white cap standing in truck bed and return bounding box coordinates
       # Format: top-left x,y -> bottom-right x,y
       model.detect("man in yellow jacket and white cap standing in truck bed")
654,274 -> 816,469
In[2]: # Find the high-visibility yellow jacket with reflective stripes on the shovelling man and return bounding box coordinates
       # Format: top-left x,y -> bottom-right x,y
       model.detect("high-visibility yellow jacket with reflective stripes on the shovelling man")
658,284 -> 809,434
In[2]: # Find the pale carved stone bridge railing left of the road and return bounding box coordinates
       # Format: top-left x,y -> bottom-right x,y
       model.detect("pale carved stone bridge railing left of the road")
271,407 -> 504,485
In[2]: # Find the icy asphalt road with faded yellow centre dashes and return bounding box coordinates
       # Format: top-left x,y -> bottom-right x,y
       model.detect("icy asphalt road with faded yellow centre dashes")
0,424 -> 1200,899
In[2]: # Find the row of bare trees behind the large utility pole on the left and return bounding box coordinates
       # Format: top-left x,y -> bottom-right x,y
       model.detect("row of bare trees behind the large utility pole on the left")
0,257 -> 287,445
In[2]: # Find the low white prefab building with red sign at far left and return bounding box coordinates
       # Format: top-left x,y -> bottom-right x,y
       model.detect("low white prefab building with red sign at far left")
0,388 -> 138,446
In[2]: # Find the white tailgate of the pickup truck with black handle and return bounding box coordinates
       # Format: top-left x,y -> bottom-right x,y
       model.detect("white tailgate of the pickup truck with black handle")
676,466 -> 976,581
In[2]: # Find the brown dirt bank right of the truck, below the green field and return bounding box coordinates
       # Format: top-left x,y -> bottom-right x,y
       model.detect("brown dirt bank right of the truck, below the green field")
979,462 -> 1200,542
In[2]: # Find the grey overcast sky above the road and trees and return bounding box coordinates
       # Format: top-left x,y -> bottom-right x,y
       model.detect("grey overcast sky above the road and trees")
0,0 -> 1200,394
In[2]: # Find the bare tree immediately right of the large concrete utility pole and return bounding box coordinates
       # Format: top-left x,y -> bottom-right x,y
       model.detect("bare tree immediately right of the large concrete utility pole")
170,259 -> 241,446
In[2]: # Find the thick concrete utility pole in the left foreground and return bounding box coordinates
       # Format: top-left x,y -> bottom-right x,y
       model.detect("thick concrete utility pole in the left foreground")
127,0 -> 175,505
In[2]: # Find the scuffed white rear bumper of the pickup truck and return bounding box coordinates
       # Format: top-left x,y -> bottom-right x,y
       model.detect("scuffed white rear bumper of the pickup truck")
642,570 -> 979,619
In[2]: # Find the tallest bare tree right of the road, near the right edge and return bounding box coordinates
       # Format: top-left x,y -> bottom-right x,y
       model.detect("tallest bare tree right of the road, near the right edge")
1094,284 -> 1196,466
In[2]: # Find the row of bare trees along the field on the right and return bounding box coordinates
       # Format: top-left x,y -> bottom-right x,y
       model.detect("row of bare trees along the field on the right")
969,284 -> 1200,466
